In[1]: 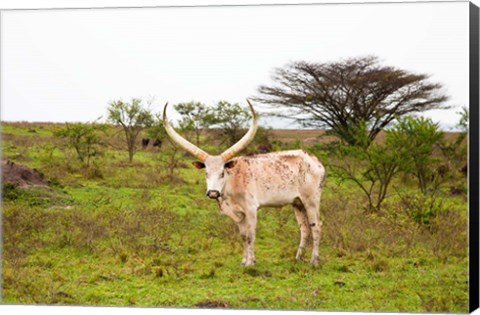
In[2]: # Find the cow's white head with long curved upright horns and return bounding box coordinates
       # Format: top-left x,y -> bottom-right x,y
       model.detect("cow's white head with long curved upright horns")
163,100 -> 257,199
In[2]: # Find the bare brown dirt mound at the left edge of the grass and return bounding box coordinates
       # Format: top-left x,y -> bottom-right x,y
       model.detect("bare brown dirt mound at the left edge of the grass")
2,160 -> 48,187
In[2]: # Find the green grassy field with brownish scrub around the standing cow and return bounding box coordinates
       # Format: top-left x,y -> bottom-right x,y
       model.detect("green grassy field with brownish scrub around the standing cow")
2,123 -> 468,313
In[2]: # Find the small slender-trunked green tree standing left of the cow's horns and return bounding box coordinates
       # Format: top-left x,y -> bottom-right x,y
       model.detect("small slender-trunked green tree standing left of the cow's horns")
107,98 -> 153,162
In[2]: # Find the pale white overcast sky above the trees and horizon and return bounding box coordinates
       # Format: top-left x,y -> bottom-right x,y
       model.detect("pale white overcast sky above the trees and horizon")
1,2 -> 469,128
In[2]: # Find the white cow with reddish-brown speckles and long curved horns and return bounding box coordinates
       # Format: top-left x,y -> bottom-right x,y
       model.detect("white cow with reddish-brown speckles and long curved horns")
163,100 -> 325,266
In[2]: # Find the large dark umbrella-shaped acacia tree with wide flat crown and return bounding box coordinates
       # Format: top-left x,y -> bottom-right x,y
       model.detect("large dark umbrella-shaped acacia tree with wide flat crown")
254,56 -> 447,145
